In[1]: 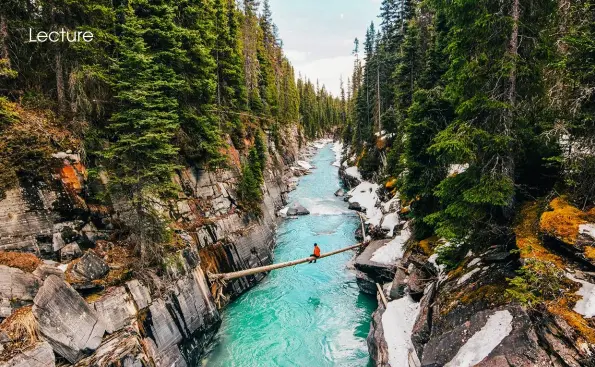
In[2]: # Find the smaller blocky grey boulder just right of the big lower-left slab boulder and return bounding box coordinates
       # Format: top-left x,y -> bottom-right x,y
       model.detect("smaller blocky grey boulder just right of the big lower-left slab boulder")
93,287 -> 136,334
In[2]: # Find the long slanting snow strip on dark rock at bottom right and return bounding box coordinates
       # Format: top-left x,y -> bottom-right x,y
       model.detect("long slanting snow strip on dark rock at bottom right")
444,310 -> 512,367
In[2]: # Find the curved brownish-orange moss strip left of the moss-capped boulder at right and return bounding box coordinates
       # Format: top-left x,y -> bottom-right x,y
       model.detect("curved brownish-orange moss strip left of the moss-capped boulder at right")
514,201 -> 564,269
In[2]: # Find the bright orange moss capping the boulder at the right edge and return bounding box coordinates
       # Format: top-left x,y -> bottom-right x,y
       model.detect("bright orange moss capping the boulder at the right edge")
539,197 -> 595,245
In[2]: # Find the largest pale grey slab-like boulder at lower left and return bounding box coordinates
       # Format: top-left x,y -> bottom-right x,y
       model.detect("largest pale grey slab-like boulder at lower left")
33,275 -> 105,363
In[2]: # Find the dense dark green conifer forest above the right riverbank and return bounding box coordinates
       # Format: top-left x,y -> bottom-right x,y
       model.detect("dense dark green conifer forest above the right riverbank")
343,0 -> 595,247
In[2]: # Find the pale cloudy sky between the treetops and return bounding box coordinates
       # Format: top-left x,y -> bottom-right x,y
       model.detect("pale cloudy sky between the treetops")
269,0 -> 381,96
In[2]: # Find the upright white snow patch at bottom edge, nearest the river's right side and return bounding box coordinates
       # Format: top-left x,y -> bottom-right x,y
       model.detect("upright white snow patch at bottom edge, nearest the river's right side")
382,296 -> 419,366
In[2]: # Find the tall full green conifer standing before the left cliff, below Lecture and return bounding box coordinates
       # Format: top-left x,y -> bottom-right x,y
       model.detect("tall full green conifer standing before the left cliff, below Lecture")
102,1 -> 182,261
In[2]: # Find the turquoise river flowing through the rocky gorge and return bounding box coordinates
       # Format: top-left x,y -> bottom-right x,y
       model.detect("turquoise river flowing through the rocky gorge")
202,144 -> 376,367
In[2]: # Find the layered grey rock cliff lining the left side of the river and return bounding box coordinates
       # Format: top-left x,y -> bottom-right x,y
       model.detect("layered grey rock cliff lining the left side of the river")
0,131 -> 298,367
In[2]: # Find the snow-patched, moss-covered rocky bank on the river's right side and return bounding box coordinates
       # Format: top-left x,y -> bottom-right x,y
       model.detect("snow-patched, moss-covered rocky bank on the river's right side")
340,146 -> 595,367
